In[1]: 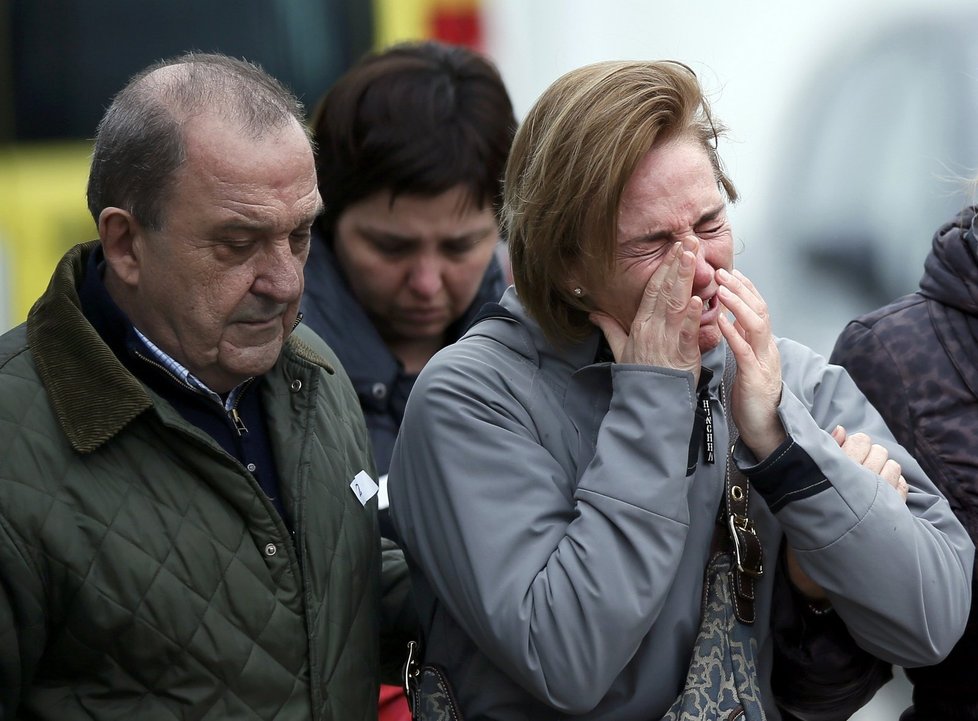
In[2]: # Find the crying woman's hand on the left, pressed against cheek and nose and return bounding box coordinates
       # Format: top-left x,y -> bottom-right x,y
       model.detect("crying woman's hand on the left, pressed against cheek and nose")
590,238 -> 703,384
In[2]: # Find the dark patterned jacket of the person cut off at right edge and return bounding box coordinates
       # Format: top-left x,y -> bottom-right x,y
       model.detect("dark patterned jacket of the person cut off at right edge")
832,207 -> 978,721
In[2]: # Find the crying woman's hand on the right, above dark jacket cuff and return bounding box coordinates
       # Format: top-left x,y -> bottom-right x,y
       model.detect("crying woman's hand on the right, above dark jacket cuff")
716,268 -> 787,459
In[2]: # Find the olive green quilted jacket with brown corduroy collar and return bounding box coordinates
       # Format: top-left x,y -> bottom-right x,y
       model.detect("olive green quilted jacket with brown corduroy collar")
0,243 -> 406,721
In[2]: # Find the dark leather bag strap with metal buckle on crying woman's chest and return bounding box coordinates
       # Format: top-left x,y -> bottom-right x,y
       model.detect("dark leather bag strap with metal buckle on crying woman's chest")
720,345 -> 764,624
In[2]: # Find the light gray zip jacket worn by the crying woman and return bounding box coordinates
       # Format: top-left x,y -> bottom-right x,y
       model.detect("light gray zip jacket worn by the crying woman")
390,289 -> 974,721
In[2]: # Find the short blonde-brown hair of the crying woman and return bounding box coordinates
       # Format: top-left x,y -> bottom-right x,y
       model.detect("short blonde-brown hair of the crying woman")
502,61 -> 737,343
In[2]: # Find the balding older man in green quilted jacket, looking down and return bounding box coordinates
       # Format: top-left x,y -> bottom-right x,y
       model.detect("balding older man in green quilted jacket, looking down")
0,55 -> 410,721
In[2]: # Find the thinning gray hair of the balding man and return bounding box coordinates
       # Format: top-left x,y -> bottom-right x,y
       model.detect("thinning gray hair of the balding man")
88,53 -> 308,230
